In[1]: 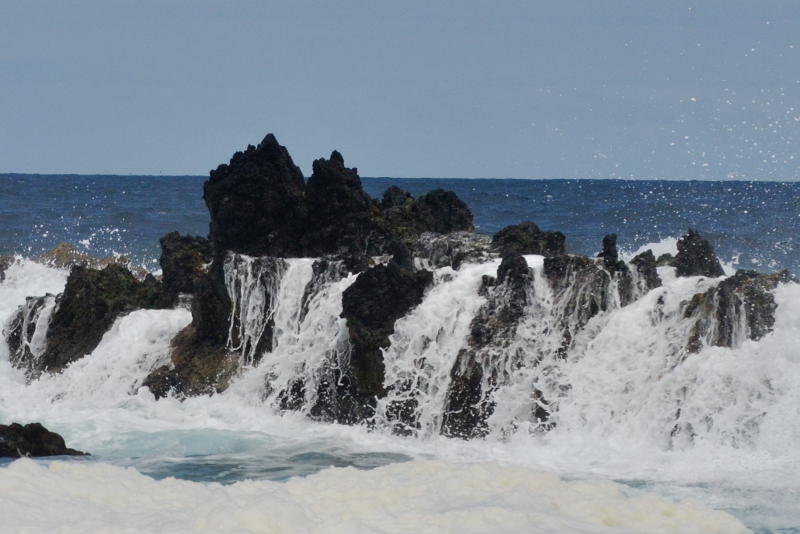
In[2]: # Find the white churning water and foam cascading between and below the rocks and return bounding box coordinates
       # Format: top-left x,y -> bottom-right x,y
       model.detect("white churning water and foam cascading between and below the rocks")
0,239 -> 800,533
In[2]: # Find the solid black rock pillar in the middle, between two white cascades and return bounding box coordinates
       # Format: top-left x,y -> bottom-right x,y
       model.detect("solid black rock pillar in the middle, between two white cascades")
336,261 -> 433,422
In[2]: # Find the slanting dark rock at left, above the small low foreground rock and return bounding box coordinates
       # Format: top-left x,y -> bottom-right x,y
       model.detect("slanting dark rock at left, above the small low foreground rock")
33,264 -> 160,372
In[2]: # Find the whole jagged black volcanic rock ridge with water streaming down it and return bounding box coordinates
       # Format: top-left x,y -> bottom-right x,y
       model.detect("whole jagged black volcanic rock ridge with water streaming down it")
0,134 -> 791,438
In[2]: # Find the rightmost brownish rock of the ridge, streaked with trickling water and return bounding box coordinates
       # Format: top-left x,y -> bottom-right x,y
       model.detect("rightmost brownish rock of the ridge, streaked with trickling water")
684,270 -> 792,352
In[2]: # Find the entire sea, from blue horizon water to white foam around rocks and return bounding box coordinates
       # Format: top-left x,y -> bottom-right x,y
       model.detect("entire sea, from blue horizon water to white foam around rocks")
0,175 -> 800,533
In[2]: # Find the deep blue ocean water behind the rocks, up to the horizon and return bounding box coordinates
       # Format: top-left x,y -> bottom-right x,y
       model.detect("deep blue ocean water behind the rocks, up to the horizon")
0,174 -> 800,274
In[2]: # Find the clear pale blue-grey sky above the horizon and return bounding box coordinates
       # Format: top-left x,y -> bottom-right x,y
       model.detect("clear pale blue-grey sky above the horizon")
0,0 -> 800,180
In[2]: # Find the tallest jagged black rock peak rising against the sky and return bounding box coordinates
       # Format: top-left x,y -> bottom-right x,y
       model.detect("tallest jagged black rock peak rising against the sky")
203,134 -> 305,256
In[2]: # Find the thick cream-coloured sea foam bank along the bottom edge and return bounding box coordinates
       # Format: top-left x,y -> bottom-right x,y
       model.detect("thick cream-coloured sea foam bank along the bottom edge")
0,459 -> 749,534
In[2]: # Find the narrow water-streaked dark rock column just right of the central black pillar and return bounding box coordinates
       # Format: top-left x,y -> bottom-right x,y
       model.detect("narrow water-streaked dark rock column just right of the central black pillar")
442,254 -> 533,439
